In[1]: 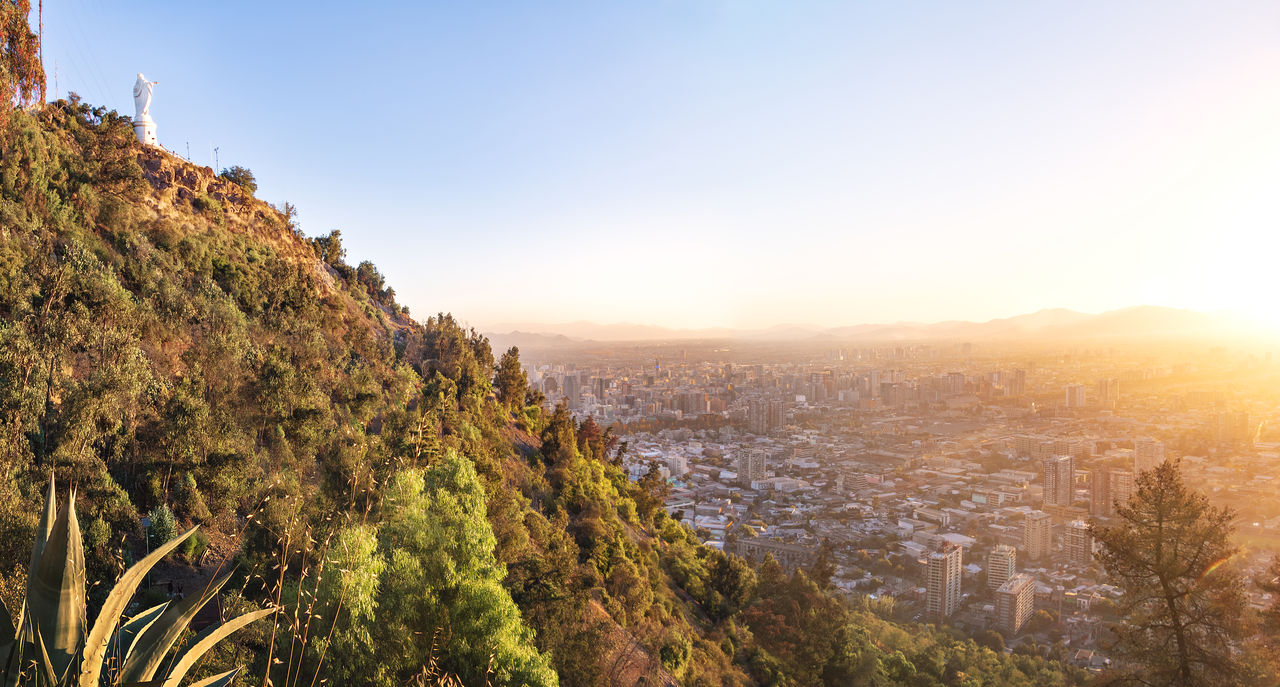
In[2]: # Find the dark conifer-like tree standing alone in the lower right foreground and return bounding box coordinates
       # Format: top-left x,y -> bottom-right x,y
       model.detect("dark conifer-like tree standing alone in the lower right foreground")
1089,461 -> 1251,687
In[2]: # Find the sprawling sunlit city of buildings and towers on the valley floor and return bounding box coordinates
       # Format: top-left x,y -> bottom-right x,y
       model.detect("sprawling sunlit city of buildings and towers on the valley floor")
530,347 -> 1280,660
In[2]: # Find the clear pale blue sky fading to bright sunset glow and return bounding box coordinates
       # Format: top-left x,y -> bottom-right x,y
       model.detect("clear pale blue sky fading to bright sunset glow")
45,0 -> 1280,328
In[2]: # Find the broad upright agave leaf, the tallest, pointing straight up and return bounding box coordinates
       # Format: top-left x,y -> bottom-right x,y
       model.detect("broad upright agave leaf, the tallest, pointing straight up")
27,493 -> 88,678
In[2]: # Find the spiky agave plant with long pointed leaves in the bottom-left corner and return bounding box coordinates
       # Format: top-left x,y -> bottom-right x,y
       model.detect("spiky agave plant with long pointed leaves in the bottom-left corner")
0,475 -> 276,687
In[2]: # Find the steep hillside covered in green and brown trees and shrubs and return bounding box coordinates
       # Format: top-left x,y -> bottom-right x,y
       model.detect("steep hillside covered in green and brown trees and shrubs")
0,73 -> 1083,686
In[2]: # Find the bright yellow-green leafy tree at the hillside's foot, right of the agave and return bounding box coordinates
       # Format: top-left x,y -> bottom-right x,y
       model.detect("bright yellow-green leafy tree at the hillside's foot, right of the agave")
314,452 -> 557,684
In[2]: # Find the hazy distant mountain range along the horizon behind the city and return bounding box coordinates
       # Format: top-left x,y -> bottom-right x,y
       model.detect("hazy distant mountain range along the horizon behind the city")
488,306 -> 1257,348
